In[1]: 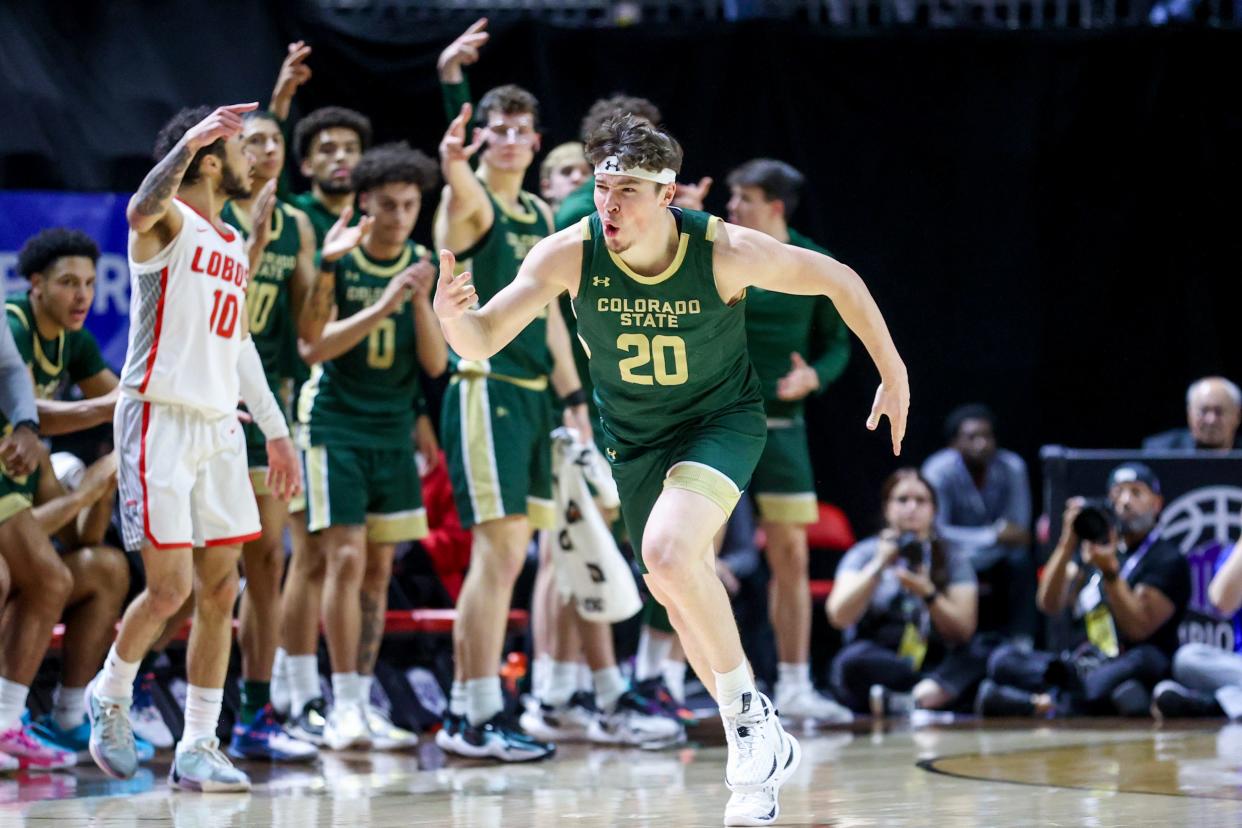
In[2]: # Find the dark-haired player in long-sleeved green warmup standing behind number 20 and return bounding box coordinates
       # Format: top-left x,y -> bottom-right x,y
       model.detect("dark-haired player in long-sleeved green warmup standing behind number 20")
729,158 -> 853,722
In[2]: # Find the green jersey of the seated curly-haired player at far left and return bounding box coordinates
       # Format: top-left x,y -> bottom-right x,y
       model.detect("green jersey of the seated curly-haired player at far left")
0,294 -> 108,433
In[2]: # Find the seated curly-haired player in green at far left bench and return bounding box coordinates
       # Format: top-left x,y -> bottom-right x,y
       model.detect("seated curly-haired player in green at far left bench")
0,227 -> 128,767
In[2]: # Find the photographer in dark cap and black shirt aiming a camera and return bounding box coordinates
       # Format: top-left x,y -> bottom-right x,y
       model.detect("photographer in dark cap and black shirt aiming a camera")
976,463 -> 1190,716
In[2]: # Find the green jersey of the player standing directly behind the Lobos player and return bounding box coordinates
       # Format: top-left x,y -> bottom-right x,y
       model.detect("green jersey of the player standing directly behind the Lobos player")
220,201 -> 302,398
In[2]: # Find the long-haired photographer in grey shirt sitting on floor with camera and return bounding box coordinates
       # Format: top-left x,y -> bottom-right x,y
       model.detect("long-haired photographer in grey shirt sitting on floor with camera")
827,468 -> 986,715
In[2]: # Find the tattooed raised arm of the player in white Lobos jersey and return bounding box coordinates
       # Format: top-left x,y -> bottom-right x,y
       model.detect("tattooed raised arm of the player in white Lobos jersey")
125,103 -> 258,262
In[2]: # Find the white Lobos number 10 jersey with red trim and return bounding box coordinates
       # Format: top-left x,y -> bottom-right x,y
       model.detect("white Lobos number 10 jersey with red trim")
120,199 -> 250,413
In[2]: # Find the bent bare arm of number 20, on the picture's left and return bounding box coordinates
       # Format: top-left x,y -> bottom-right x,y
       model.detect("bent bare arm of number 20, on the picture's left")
433,227 -> 582,360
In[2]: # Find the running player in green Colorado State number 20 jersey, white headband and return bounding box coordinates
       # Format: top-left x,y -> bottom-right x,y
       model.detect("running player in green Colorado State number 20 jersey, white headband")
435,115 -> 909,826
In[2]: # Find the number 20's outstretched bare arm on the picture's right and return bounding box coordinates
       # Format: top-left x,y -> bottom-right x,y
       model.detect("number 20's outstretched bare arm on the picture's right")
713,222 -> 910,454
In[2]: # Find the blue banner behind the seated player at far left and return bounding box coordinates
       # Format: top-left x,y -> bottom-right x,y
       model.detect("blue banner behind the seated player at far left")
0,191 -> 129,374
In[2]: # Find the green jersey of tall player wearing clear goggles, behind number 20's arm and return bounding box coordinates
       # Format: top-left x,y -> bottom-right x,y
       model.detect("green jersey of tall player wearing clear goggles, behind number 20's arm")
448,191 -> 553,380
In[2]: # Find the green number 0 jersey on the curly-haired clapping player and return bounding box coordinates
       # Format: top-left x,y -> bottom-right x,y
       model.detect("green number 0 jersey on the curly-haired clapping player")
298,242 -> 427,448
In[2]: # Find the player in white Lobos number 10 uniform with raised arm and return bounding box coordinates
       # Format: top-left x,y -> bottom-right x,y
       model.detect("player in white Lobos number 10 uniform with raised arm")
86,103 -> 301,792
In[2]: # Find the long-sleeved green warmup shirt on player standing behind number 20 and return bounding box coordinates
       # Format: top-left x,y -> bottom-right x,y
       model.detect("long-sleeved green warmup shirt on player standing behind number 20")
746,230 -> 850,417
